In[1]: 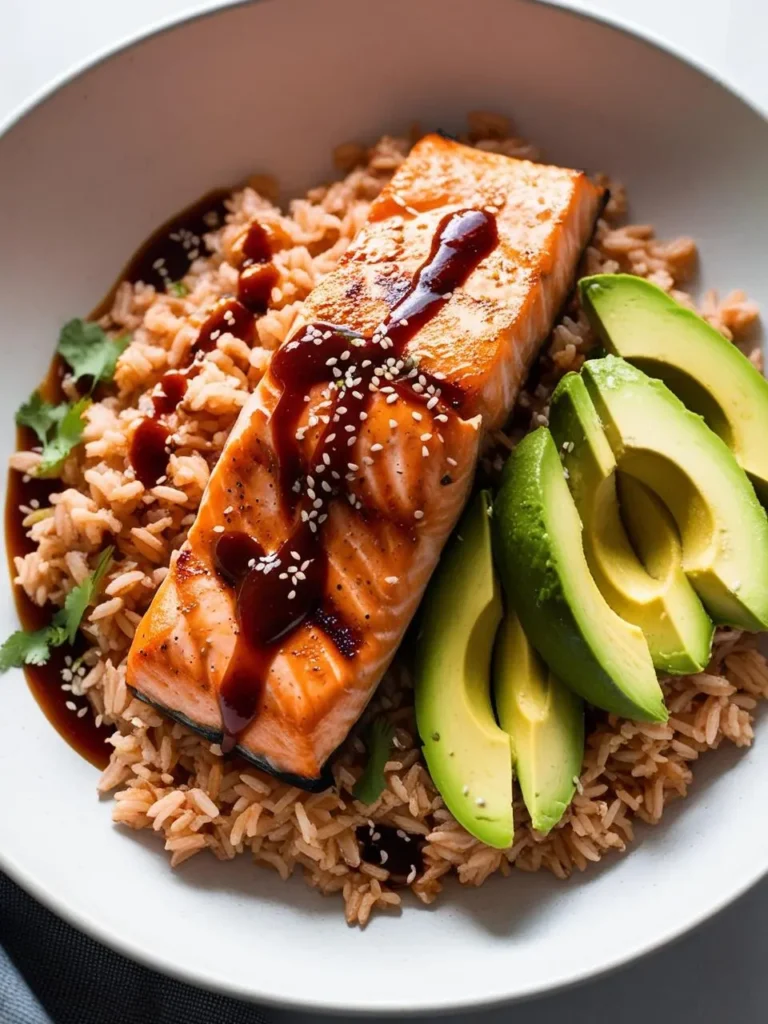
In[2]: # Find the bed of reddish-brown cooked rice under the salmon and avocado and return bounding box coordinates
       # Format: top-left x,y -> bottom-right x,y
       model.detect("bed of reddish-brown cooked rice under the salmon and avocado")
11,114 -> 768,925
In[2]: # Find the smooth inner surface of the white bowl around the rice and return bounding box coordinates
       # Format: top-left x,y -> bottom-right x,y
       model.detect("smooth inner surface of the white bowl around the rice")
0,0 -> 768,1011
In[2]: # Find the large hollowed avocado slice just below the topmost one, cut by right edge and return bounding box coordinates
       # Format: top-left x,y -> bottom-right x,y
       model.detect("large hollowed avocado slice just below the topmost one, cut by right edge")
582,355 -> 768,631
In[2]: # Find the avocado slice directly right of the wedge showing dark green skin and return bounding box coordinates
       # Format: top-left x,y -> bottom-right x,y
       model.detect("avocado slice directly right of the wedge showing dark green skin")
550,374 -> 713,675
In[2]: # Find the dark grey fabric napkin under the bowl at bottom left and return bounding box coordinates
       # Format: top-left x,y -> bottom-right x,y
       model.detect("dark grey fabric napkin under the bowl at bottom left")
0,873 -> 267,1024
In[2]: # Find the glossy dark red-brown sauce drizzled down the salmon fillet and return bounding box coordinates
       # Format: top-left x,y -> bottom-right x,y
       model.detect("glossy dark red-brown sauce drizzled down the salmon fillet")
215,209 -> 498,750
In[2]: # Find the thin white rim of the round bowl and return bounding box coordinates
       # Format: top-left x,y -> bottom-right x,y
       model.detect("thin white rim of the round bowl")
0,0 -> 768,1017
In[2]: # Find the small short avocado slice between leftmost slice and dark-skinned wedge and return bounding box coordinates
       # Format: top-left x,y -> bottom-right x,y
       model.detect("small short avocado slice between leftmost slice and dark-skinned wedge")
494,610 -> 584,833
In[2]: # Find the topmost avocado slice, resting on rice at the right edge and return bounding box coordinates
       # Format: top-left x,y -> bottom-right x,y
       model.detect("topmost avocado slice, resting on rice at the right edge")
579,273 -> 768,503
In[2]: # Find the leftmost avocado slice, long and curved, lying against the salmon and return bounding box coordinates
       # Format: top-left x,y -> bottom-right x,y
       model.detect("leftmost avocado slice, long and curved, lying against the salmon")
415,490 -> 514,849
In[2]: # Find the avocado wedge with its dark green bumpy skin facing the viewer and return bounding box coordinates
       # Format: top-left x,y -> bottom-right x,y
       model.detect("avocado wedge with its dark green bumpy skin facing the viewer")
494,427 -> 667,722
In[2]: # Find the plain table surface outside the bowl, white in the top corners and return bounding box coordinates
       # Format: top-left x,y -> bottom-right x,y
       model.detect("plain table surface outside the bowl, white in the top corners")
0,0 -> 768,1024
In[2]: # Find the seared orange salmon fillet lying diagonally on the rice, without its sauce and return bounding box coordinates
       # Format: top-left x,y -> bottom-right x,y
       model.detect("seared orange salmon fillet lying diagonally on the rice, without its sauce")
128,135 -> 604,786
